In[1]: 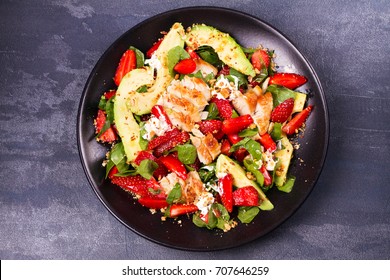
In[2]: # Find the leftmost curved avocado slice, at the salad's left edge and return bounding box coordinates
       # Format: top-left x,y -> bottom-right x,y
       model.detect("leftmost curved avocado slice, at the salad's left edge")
114,67 -> 154,163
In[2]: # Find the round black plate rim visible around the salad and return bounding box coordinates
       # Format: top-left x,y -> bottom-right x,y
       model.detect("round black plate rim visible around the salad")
77,7 -> 329,251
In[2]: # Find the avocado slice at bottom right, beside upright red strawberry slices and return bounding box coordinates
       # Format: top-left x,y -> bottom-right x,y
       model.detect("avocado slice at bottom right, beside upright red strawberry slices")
215,154 -> 274,210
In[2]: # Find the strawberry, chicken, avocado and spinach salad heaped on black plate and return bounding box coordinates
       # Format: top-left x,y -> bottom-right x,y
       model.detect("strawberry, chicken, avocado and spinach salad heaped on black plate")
94,23 -> 313,231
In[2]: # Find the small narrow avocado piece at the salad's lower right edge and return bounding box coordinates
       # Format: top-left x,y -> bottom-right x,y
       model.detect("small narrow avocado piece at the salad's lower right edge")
275,135 -> 293,187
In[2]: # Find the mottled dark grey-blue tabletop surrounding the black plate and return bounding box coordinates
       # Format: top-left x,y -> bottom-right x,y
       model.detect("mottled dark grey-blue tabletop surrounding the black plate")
0,0 -> 390,259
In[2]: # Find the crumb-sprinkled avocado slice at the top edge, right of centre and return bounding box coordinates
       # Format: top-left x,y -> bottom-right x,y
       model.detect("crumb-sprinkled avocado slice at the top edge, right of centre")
185,24 -> 256,77
